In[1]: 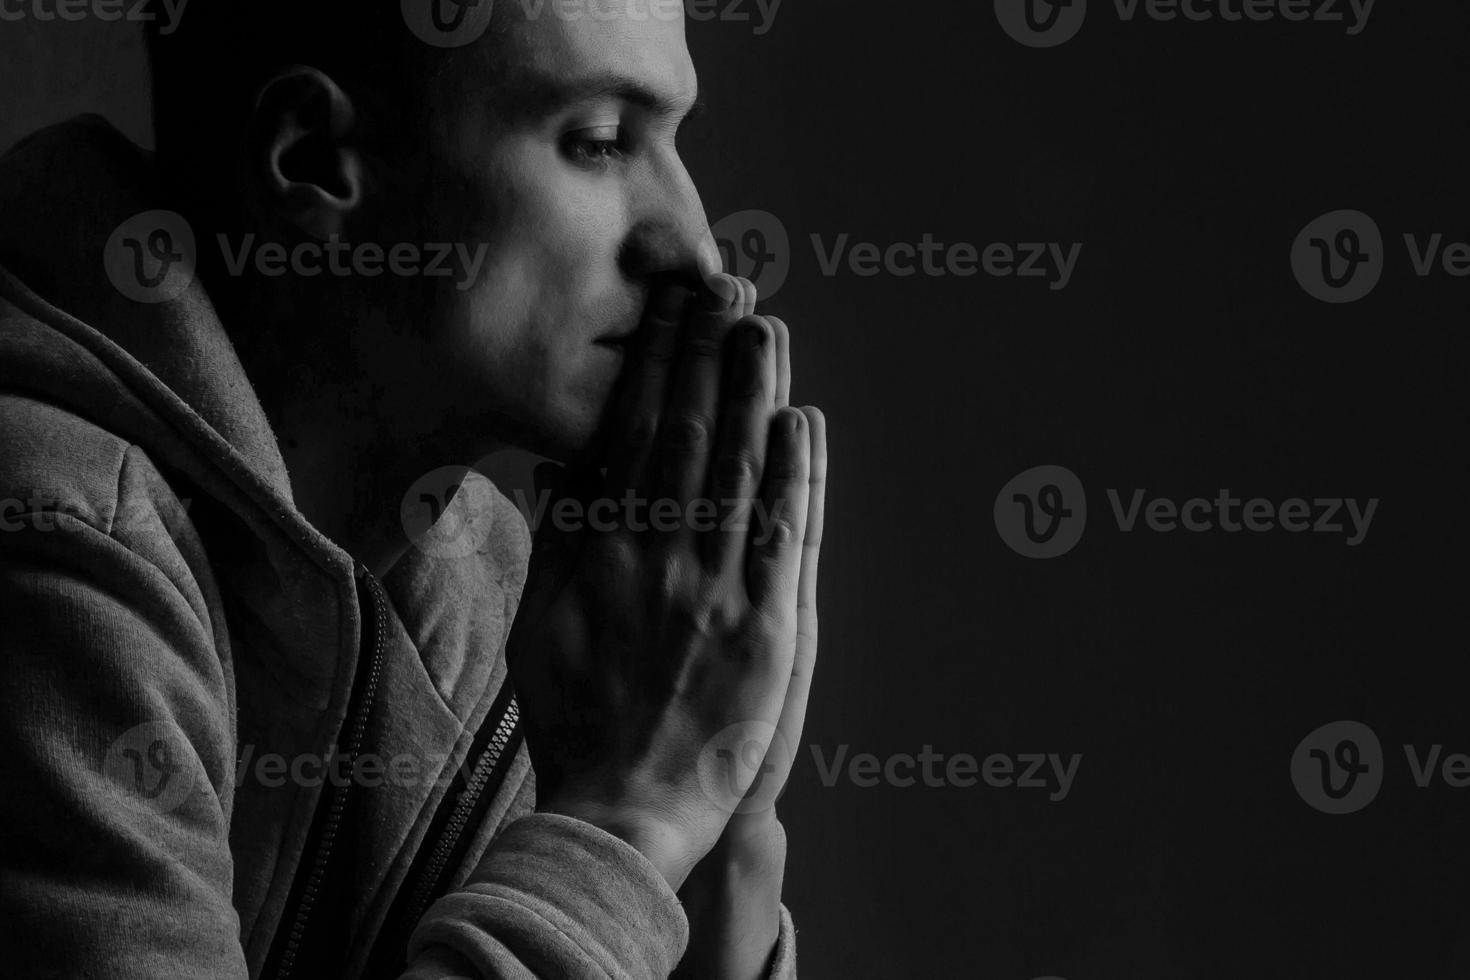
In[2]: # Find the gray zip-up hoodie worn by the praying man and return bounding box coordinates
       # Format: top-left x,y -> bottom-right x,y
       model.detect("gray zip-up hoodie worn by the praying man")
0,118 -> 795,980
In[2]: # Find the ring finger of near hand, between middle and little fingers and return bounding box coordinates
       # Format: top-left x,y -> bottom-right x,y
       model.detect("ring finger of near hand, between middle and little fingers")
703,316 -> 776,572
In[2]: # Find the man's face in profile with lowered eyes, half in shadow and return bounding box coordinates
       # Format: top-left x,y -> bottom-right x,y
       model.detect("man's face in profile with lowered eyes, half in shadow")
382,3 -> 719,461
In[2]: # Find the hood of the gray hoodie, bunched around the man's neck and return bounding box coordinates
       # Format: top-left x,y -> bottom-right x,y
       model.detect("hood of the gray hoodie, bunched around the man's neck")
0,116 -> 529,686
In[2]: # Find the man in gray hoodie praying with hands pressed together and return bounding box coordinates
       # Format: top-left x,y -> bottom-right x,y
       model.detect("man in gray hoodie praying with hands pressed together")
0,0 -> 826,979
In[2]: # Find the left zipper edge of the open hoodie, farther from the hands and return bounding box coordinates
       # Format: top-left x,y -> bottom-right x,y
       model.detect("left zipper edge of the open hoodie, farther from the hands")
265,566 -> 387,980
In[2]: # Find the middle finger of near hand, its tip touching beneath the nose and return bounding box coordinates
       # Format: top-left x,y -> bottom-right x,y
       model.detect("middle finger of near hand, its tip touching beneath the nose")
654,273 -> 741,505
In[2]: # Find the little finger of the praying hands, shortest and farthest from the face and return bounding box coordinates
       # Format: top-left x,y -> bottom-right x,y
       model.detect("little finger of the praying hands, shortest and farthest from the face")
745,408 -> 811,605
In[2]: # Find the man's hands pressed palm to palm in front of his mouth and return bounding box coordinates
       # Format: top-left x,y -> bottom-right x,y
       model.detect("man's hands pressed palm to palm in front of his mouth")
509,276 -> 811,889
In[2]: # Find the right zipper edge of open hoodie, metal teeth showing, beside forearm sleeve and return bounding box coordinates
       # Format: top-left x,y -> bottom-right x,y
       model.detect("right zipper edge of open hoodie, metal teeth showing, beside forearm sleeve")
363,679 -> 525,980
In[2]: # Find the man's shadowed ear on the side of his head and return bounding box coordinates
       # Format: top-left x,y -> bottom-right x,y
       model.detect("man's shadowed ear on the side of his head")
250,68 -> 365,241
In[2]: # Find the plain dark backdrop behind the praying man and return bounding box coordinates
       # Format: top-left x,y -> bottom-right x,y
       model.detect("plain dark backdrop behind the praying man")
0,0 -> 1470,980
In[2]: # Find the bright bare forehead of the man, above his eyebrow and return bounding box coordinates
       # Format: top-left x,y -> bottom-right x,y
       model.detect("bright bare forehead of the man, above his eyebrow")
495,0 -> 697,101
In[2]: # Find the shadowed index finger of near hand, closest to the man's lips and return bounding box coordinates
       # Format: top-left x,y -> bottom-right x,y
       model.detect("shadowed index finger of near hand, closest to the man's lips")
607,285 -> 689,489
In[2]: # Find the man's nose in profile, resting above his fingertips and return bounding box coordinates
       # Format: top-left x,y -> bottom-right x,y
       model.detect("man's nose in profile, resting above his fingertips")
620,160 -> 722,289
